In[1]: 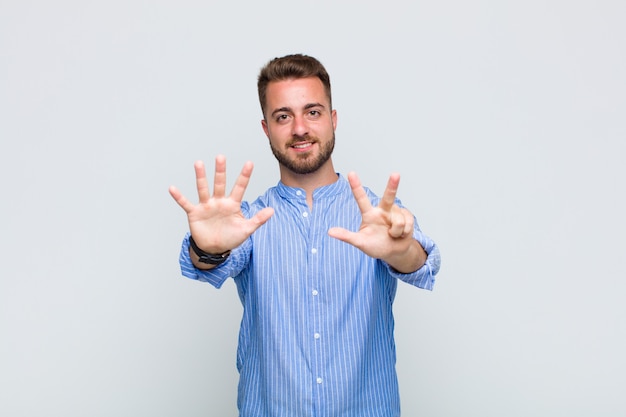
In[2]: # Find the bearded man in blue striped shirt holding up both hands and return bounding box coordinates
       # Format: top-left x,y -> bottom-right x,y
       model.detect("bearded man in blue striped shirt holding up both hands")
170,55 -> 440,417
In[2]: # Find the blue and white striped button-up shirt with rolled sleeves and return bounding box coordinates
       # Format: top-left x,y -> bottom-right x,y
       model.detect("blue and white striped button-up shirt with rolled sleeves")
180,176 -> 440,417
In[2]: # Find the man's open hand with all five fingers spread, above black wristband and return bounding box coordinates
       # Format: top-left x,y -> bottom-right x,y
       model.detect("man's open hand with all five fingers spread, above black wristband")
169,155 -> 274,269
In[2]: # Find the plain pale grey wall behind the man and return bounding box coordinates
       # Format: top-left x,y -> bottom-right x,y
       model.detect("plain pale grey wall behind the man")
0,0 -> 626,417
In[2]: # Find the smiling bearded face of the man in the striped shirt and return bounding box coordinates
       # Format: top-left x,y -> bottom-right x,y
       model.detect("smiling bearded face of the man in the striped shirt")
261,77 -> 337,174
